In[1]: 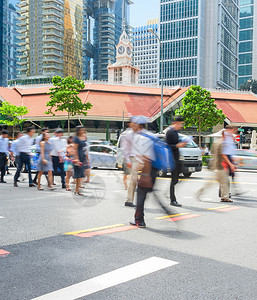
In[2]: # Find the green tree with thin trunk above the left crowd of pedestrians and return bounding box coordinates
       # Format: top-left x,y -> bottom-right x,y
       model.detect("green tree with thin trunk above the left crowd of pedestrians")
45,76 -> 92,134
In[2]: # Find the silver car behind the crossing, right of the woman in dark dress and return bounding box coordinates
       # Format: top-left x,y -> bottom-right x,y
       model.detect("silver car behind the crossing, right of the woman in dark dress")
89,144 -> 117,168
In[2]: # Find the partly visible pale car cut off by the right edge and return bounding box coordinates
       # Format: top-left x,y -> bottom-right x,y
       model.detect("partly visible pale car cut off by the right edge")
233,149 -> 257,170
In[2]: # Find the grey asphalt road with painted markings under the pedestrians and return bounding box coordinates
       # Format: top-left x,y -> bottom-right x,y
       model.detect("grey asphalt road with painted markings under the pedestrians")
0,170 -> 257,300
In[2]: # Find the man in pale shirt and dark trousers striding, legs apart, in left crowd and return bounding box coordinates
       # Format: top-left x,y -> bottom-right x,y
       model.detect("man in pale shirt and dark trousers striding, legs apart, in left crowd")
14,127 -> 36,187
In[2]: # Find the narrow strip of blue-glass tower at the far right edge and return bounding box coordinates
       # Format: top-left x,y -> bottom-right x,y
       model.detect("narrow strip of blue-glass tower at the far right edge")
238,0 -> 257,88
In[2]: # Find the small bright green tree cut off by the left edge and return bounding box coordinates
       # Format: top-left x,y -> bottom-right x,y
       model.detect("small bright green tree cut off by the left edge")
0,101 -> 29,138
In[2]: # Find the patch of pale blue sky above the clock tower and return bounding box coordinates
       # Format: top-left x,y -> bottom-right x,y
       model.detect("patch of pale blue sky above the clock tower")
130,0 -> 160,27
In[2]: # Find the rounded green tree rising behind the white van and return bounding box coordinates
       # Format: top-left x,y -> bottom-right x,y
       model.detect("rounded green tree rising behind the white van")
176,86 -> 226,146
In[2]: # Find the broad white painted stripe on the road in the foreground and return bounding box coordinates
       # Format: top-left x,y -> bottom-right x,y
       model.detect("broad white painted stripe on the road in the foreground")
32,257 -> 178,300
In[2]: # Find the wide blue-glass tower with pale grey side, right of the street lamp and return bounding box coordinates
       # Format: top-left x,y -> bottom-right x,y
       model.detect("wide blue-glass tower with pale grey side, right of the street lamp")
160,0 -> 239,89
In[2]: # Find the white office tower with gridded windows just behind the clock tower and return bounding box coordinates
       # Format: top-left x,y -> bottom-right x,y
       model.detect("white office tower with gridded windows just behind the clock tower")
132,19 -> 159,85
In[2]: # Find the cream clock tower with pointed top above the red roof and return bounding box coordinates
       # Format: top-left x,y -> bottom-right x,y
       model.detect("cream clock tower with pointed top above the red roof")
107,30 -> 139,84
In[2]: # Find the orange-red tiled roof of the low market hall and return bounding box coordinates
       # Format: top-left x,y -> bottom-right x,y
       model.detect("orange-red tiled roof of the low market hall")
0,83 -> 257,124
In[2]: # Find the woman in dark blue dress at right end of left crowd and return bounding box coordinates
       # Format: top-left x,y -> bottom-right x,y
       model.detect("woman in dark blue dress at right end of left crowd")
73,126 -> 86,196
